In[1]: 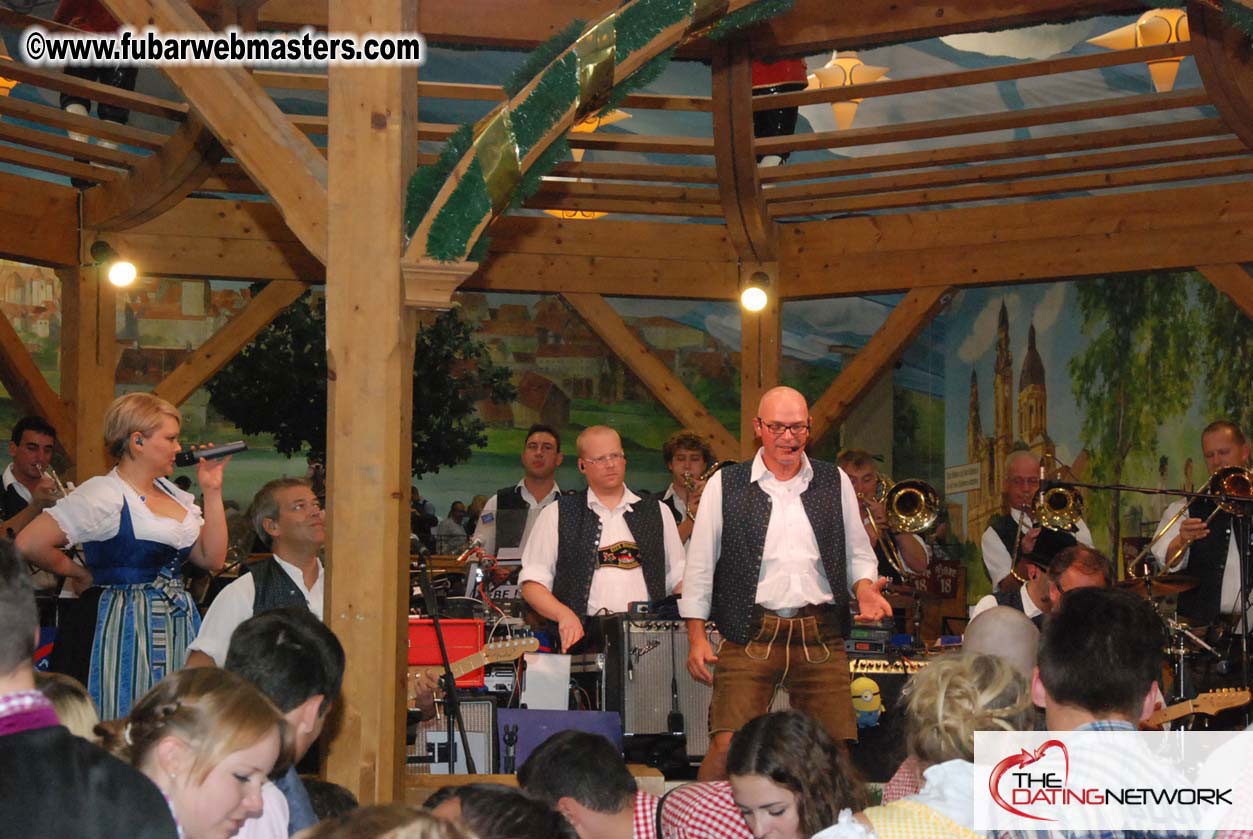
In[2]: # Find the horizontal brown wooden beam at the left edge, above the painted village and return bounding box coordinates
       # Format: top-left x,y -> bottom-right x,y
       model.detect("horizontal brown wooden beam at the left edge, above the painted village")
0,172 -> 79,268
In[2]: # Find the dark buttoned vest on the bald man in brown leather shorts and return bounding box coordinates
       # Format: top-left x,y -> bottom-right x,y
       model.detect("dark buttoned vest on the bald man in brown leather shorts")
709,460 -> 848,644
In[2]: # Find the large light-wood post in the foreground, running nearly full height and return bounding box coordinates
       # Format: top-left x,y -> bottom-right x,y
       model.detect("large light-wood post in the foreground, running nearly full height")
326,0 -> 417,804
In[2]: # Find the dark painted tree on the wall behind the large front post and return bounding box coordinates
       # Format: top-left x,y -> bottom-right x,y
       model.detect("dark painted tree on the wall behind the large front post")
207,294 -> 516,477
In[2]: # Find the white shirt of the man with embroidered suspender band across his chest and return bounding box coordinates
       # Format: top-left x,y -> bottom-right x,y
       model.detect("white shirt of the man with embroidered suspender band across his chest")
517,486 -> 683,615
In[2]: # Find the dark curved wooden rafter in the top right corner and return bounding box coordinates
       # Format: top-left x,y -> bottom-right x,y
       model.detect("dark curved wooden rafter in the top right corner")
1188,0 -> 1253,149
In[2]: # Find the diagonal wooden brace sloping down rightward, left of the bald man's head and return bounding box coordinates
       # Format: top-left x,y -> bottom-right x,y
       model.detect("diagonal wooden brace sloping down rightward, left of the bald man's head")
564,293 -> 739,458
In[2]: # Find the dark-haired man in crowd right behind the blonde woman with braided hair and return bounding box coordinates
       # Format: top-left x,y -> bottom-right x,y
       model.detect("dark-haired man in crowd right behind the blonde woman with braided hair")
224,606 -> 345,839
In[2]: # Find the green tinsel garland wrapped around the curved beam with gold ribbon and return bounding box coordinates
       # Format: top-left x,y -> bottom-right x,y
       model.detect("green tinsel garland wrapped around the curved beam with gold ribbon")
405,0 -> 793,262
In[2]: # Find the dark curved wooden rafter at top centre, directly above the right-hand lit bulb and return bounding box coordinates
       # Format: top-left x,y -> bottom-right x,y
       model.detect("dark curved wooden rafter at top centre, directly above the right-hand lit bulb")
703,38 -> 774,262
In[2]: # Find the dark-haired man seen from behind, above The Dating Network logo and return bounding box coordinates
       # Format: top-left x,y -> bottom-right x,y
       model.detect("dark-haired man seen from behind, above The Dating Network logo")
1000,586 -> 1194,839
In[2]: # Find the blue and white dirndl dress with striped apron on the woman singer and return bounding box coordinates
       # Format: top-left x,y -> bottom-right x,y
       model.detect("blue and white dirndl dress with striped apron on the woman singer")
49,470 -> 204,720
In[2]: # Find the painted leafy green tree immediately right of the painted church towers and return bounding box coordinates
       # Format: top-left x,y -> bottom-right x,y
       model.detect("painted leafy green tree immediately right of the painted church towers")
1069,274 -> 1197,558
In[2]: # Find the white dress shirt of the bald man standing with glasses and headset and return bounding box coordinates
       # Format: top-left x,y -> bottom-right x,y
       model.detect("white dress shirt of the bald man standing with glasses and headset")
679,450 -> 878,620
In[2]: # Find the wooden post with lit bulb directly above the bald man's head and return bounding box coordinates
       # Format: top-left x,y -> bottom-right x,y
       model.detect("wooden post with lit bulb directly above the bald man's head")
739,263 -> 783,460
